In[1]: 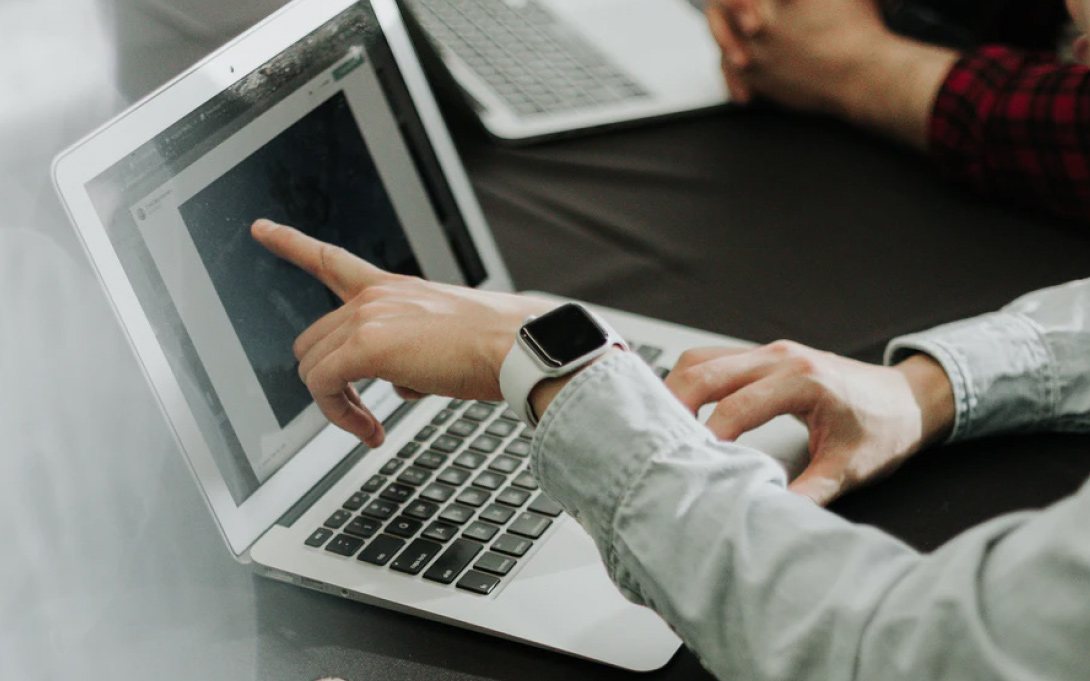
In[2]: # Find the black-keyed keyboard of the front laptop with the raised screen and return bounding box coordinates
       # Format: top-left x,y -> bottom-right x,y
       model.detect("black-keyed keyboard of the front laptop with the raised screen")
305,343 -> 668,595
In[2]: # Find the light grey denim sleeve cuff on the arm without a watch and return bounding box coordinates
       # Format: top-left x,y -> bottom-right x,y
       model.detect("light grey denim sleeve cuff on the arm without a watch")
886,279 -> 1090,440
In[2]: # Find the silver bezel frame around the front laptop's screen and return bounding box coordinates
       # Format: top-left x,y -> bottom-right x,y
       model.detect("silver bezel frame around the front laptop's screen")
46,0 -> 512,559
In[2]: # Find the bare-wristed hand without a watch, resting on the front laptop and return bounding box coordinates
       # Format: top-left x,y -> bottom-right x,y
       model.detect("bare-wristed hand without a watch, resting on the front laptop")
666,341 -> 954,504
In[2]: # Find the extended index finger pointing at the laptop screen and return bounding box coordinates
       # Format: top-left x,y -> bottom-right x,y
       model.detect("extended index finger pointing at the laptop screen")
250,219 -> 389,301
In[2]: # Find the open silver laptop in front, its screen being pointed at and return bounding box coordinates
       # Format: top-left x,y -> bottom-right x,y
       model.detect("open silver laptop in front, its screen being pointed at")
55,0 -> 806,670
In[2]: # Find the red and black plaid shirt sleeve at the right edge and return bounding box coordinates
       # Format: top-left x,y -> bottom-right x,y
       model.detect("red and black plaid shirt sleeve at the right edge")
930,47 -> 1090,219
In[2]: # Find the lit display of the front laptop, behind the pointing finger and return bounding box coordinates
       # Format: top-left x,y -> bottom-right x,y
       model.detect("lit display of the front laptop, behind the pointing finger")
80,3 -> 486,504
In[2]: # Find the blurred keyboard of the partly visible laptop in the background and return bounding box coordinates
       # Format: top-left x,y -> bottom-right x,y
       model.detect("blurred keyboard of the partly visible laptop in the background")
409,0 -> 649,118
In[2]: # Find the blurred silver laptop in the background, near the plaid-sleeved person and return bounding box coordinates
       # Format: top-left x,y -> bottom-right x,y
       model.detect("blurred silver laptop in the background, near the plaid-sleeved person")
403,0 -> 729,141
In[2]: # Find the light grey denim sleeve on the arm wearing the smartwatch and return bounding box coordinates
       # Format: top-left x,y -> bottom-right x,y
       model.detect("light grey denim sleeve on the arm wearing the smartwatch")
532,356 -> 1090,680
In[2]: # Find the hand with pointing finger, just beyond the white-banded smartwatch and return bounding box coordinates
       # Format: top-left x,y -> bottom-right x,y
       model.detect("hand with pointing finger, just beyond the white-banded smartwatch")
252,220 -> 552,447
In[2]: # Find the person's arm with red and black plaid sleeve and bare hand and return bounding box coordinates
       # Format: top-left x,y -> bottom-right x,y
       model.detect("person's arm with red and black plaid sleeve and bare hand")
707,0 -> 1090,218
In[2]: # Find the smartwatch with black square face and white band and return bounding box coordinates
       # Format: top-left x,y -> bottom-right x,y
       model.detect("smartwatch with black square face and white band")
499,303 -> 628,426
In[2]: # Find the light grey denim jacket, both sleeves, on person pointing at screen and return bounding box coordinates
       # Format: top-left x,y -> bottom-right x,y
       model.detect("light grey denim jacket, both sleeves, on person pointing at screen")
532,280 -> 1090,681
